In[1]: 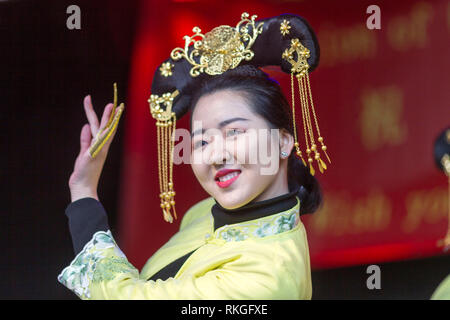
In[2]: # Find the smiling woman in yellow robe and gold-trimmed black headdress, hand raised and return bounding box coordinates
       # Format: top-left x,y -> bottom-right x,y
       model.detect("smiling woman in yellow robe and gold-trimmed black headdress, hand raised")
58,14 -> 326,300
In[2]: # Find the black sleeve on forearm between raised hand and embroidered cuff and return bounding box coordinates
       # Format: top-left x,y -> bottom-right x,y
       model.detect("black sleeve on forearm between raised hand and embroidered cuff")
65,198 -> 109,255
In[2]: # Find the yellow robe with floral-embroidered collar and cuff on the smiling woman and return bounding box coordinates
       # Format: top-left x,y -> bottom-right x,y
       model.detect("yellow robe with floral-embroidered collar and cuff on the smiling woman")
58,198 -> 312,300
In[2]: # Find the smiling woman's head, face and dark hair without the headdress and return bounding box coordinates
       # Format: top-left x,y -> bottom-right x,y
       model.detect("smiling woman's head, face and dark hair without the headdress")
191,65 -> 321,213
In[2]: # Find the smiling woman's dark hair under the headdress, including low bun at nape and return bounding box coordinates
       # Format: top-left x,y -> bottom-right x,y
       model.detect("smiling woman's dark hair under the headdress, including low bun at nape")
190,65 -> 322,214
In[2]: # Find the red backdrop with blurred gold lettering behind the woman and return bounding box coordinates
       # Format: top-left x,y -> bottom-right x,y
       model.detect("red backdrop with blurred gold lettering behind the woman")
119,0 -> 450,269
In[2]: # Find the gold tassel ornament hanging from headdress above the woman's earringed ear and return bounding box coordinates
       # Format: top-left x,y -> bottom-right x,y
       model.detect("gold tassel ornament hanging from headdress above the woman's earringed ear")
282,38 -> 331,175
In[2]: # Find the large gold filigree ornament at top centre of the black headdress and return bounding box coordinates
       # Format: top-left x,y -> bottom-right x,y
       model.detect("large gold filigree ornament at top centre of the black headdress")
170,12 -> 263,77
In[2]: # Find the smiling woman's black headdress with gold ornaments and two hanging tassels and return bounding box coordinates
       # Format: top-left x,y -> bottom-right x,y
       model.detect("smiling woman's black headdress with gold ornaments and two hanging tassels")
148,13 -> 331,222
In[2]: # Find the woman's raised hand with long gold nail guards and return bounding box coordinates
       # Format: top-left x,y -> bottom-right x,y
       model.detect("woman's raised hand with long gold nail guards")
69,95 -> 124,202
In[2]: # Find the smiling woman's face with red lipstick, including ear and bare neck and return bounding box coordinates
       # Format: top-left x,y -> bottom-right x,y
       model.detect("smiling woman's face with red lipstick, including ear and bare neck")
191,90 -> 293,209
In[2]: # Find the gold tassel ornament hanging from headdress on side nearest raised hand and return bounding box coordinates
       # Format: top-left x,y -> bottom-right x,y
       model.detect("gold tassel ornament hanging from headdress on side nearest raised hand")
148,90 -> 179,223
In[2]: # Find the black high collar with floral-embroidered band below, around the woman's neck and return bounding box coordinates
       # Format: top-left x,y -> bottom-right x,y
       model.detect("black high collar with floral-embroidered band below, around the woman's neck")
211,191 -> 300,242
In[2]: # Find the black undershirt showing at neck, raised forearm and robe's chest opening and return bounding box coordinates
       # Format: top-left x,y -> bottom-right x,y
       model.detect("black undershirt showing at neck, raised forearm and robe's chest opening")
65,191 -> 297,281
